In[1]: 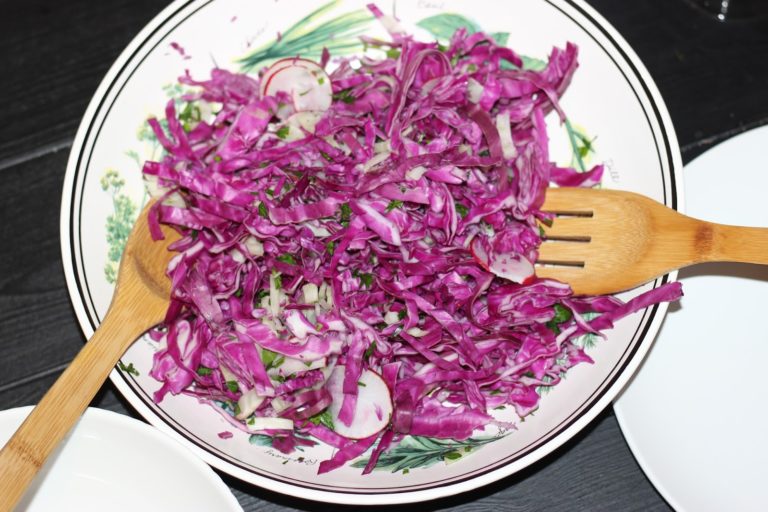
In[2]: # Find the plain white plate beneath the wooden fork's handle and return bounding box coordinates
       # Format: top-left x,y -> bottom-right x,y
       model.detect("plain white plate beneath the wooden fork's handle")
614,127 -> 768,512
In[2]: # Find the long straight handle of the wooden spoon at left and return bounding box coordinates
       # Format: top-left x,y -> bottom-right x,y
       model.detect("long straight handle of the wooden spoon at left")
0,308 -> 143,512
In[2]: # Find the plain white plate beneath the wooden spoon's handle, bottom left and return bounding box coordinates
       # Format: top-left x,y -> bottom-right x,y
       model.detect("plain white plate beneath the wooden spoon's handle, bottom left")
0,407 -> 243,512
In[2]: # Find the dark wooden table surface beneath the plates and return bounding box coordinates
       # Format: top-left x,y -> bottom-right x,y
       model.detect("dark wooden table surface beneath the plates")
0,0 -> 768,511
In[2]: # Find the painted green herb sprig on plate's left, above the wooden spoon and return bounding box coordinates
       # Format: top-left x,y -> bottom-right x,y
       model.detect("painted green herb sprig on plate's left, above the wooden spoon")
101,169 -> 138,283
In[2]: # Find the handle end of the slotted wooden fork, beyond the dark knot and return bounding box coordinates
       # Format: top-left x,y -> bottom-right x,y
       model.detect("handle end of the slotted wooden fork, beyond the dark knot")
700,224 -> 768,265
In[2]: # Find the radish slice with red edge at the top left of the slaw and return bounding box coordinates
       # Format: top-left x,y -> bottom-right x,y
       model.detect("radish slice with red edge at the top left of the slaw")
261,59 -> 333,112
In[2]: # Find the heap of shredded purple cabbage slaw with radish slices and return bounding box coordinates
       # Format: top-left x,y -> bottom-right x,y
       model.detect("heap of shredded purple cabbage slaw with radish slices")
143,11 -> 681,473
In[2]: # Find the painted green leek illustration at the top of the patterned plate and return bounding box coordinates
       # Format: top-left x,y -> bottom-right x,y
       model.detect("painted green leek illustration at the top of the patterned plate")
237,0 -> 373,71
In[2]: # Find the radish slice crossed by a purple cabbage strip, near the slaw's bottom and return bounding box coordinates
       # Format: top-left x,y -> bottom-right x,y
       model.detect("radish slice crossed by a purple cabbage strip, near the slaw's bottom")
326,366 -> 392,439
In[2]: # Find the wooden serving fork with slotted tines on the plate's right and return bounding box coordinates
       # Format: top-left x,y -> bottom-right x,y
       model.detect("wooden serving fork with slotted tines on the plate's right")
536,187 -> 768,295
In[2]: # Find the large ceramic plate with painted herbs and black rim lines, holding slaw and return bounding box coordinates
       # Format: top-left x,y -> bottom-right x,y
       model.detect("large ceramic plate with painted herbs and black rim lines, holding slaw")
61,0 -> 681,504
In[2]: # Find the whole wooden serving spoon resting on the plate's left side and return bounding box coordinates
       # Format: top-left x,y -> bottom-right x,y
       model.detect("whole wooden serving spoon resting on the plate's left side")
0,203 -> 179,512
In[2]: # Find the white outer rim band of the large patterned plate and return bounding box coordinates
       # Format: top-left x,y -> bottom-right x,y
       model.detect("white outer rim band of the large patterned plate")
60,0 -> 683,504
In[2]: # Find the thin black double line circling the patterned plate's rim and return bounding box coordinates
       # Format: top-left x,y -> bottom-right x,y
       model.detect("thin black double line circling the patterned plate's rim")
70,0 -> 677,495
